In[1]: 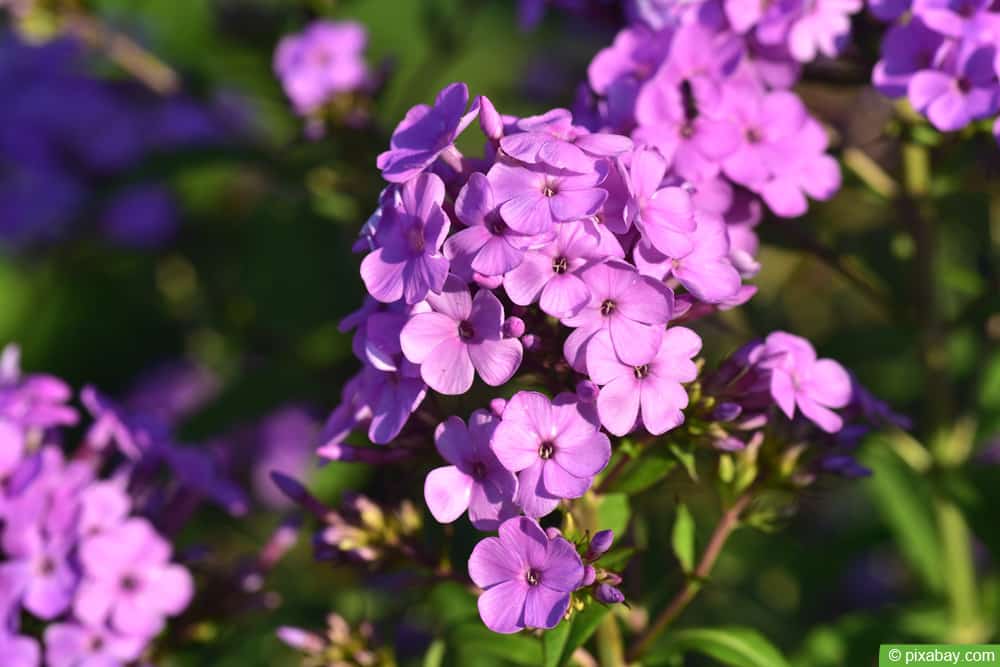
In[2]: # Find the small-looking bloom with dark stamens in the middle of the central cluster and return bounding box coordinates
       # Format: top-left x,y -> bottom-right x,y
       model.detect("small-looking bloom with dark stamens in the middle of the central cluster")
503,220 -> 608,317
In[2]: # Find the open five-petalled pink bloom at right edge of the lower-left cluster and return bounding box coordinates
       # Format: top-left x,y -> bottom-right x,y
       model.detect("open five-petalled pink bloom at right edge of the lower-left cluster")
73,518 -> 194,637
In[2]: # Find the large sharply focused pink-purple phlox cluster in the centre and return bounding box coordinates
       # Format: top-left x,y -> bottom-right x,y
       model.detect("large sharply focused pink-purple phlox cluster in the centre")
306,73 -> 900,632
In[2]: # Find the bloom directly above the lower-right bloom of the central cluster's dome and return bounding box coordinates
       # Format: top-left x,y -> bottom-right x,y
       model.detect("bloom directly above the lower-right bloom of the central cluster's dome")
563,259 -> 674,370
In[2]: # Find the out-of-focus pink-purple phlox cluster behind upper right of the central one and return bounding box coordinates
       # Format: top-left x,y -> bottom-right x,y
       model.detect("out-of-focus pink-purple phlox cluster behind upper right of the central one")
576,0 -> 848,224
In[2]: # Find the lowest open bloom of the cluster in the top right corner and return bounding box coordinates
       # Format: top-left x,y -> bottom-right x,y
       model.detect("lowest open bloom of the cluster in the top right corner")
908,45 -> 1000,132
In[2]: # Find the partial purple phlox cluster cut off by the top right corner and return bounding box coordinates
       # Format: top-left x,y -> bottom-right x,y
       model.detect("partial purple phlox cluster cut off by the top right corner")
871,0 -> 1000,141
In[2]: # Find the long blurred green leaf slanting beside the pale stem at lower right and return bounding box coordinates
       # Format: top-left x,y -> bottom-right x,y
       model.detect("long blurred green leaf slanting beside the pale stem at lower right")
861,438 -> 946,591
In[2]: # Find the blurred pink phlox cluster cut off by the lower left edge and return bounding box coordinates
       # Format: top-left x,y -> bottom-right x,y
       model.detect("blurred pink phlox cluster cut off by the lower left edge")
0,347 -> 206,667
